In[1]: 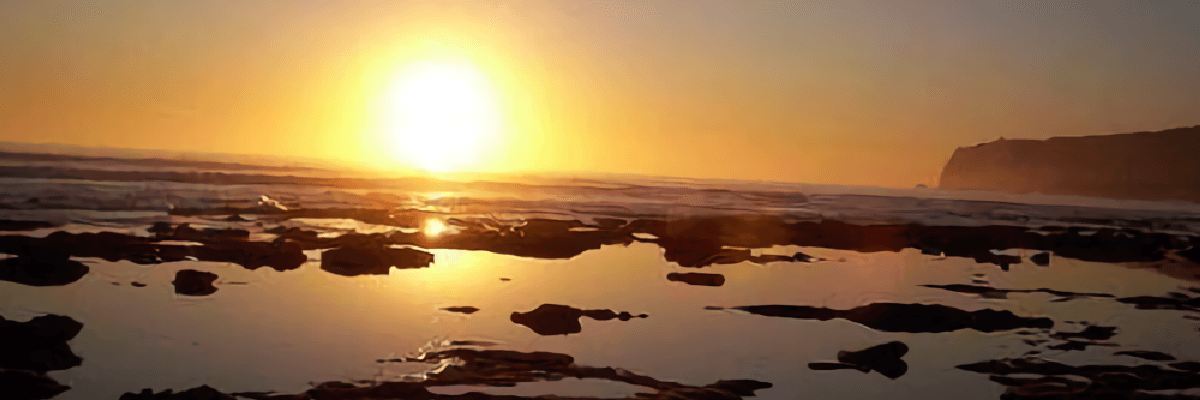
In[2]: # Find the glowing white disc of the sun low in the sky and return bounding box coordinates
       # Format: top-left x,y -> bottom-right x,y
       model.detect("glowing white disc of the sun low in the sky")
385,61 -> 500,172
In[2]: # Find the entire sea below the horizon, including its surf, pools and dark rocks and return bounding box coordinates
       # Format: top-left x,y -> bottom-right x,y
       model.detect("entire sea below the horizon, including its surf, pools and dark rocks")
0,153 -> 1200,399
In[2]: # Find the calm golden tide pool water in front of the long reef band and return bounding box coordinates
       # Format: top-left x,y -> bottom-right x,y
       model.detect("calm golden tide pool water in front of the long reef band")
0,237 -> 1200,399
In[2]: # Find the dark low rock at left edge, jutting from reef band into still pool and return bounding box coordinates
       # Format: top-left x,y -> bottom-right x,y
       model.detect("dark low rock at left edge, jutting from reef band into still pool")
0,247 -> 91,286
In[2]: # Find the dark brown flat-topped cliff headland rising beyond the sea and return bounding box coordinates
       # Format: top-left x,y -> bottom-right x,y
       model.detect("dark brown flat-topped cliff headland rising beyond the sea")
940,125 -> 1200,203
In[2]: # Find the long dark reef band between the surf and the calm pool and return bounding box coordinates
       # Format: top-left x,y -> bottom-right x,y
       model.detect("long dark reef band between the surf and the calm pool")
0,215 -> 1200,287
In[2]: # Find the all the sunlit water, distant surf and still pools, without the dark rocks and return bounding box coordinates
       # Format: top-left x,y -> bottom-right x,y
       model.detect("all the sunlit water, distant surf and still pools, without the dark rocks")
0,156 -> 1200,400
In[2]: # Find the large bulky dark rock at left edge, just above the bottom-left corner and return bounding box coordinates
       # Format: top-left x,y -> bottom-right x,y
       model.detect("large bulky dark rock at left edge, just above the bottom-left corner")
0,315 -> 83,372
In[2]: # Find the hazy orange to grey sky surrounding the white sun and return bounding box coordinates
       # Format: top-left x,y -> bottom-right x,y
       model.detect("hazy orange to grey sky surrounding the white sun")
0,0 -> 1200,187
